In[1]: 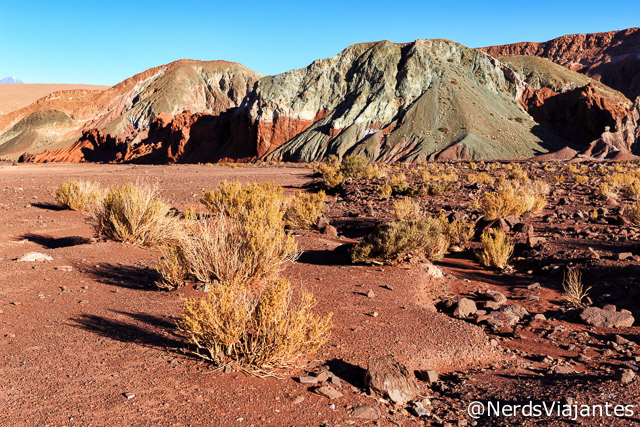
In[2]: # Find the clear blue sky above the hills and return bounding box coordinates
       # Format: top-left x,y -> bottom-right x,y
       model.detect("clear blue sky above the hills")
0,0 -> 640,85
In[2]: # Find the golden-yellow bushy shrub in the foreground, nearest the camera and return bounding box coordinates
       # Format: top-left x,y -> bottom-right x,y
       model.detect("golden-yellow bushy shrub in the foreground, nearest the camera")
178,279 -> 332,370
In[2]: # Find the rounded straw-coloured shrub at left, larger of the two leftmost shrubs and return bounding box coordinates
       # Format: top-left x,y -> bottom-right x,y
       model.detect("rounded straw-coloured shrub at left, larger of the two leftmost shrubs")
91,183 -> 183,246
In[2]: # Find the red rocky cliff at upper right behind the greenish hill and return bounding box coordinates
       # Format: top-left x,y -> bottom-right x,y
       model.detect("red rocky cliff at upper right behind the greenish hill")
481,28 -> 640,99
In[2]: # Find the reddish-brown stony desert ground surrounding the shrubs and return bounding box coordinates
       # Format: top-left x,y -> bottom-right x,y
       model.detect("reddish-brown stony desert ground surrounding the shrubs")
0,162 -> 640,426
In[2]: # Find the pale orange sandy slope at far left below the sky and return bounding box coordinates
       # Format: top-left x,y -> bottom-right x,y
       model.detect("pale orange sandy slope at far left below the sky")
0,83 -> 109,114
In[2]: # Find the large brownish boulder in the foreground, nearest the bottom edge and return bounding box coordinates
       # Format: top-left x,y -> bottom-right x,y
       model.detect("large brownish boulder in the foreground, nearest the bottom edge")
364,356 -> 419,405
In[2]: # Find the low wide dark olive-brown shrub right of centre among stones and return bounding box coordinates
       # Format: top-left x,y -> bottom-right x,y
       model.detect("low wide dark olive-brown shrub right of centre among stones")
351,217 -> 449,264
